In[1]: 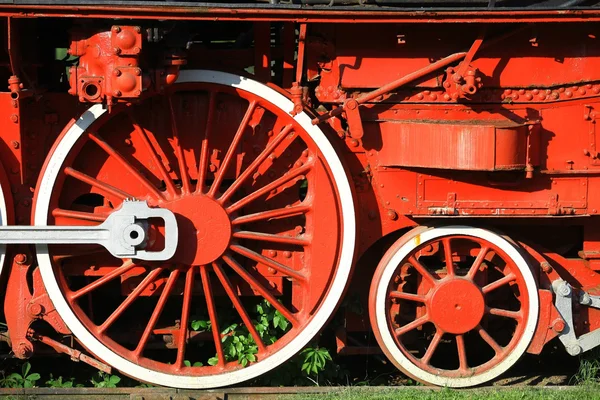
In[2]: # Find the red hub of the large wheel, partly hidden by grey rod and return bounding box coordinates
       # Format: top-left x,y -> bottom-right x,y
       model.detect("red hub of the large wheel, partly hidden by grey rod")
165,194 -> 231,265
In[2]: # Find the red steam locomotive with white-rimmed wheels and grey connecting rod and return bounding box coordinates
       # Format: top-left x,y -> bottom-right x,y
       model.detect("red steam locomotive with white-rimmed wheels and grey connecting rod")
0,1 -> 600,388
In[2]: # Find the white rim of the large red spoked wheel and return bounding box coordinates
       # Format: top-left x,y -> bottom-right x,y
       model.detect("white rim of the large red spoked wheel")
34,70 -> 356,389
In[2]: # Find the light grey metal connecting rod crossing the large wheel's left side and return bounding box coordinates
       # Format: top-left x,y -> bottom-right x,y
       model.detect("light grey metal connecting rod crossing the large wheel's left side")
0,200 -> 178,261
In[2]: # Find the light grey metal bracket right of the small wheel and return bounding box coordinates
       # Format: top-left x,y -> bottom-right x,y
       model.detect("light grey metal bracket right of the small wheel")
552,279 -> 600,356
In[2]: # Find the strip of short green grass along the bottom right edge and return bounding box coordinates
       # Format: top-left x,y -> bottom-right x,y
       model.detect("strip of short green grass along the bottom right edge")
280,385 -> 600,400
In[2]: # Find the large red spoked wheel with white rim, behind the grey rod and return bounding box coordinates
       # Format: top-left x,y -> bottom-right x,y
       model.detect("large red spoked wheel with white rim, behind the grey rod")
35,71 -> 355,388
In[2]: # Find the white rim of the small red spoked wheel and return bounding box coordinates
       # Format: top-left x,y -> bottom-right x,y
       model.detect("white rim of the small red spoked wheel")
374,226 -> 539,387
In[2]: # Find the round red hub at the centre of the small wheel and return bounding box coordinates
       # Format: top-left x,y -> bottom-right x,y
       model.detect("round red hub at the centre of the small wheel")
429,278 -> 485,334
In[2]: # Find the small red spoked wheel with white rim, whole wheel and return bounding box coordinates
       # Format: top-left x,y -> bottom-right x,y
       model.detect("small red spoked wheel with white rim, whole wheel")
369,226 -> 539,387
